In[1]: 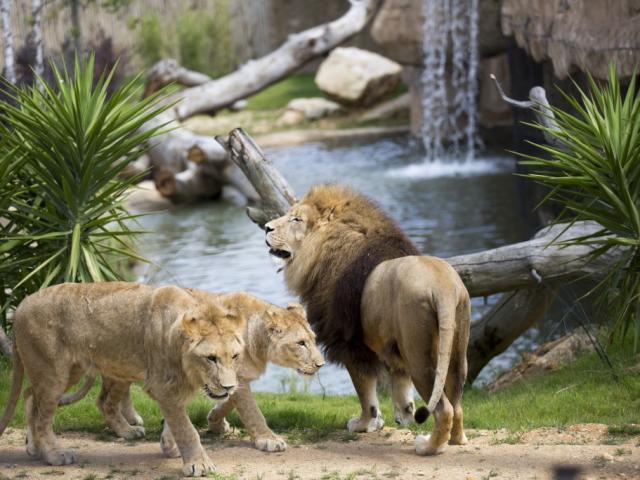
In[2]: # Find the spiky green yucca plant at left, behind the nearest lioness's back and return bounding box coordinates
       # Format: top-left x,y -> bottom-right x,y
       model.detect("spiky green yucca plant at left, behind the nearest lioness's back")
0,57 -> 167,327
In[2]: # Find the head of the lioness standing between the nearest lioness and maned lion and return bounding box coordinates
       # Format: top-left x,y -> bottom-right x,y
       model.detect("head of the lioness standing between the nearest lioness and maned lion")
264,303 -> 324,375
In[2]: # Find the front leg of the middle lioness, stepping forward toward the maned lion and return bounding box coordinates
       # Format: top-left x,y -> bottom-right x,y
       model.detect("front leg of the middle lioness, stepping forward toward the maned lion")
229,384 -> 287,452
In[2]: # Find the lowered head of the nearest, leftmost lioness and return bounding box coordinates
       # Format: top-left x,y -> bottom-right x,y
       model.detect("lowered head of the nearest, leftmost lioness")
179,299 -> 246,400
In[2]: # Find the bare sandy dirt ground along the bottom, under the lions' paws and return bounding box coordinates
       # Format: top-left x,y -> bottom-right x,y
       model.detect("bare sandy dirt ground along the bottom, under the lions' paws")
0,424 -> 640,480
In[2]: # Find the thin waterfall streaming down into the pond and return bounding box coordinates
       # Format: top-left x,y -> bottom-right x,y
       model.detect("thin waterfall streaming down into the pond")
421,0 -> 478,160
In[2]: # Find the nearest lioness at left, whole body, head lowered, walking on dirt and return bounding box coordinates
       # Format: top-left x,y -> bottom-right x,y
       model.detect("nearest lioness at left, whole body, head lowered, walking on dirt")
0,282 -> 246,476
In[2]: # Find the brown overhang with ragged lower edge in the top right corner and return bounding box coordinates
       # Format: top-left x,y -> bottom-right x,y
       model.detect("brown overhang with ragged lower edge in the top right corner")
502,0 -> 640,78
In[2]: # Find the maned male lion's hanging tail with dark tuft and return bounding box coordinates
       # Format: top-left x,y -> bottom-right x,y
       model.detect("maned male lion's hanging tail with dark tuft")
414,302 -> 457,423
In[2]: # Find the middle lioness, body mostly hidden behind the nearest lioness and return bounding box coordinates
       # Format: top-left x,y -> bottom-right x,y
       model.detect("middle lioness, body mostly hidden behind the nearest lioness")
160,293 -> 324,456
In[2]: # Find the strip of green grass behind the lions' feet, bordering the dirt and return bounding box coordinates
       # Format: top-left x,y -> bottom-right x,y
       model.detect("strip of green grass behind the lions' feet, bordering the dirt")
0,342 -> 640,444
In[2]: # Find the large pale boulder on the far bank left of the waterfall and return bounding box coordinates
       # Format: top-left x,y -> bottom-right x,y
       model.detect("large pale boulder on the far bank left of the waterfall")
316,47 -> 402,106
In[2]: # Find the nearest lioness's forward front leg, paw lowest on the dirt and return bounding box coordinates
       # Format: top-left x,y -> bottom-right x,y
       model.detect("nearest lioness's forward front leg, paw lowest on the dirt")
154,395 -> 215,477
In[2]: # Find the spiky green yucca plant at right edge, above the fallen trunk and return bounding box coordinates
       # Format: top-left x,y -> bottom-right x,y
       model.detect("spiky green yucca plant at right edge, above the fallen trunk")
521,65 -> 640,351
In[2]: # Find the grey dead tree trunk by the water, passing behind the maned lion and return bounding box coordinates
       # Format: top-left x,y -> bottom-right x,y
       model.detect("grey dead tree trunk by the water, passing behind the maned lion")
216,129 -> 622,382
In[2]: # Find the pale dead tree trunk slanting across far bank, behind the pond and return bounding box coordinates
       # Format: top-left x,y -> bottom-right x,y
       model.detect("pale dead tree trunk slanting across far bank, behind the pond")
140,0 -> 380,200
